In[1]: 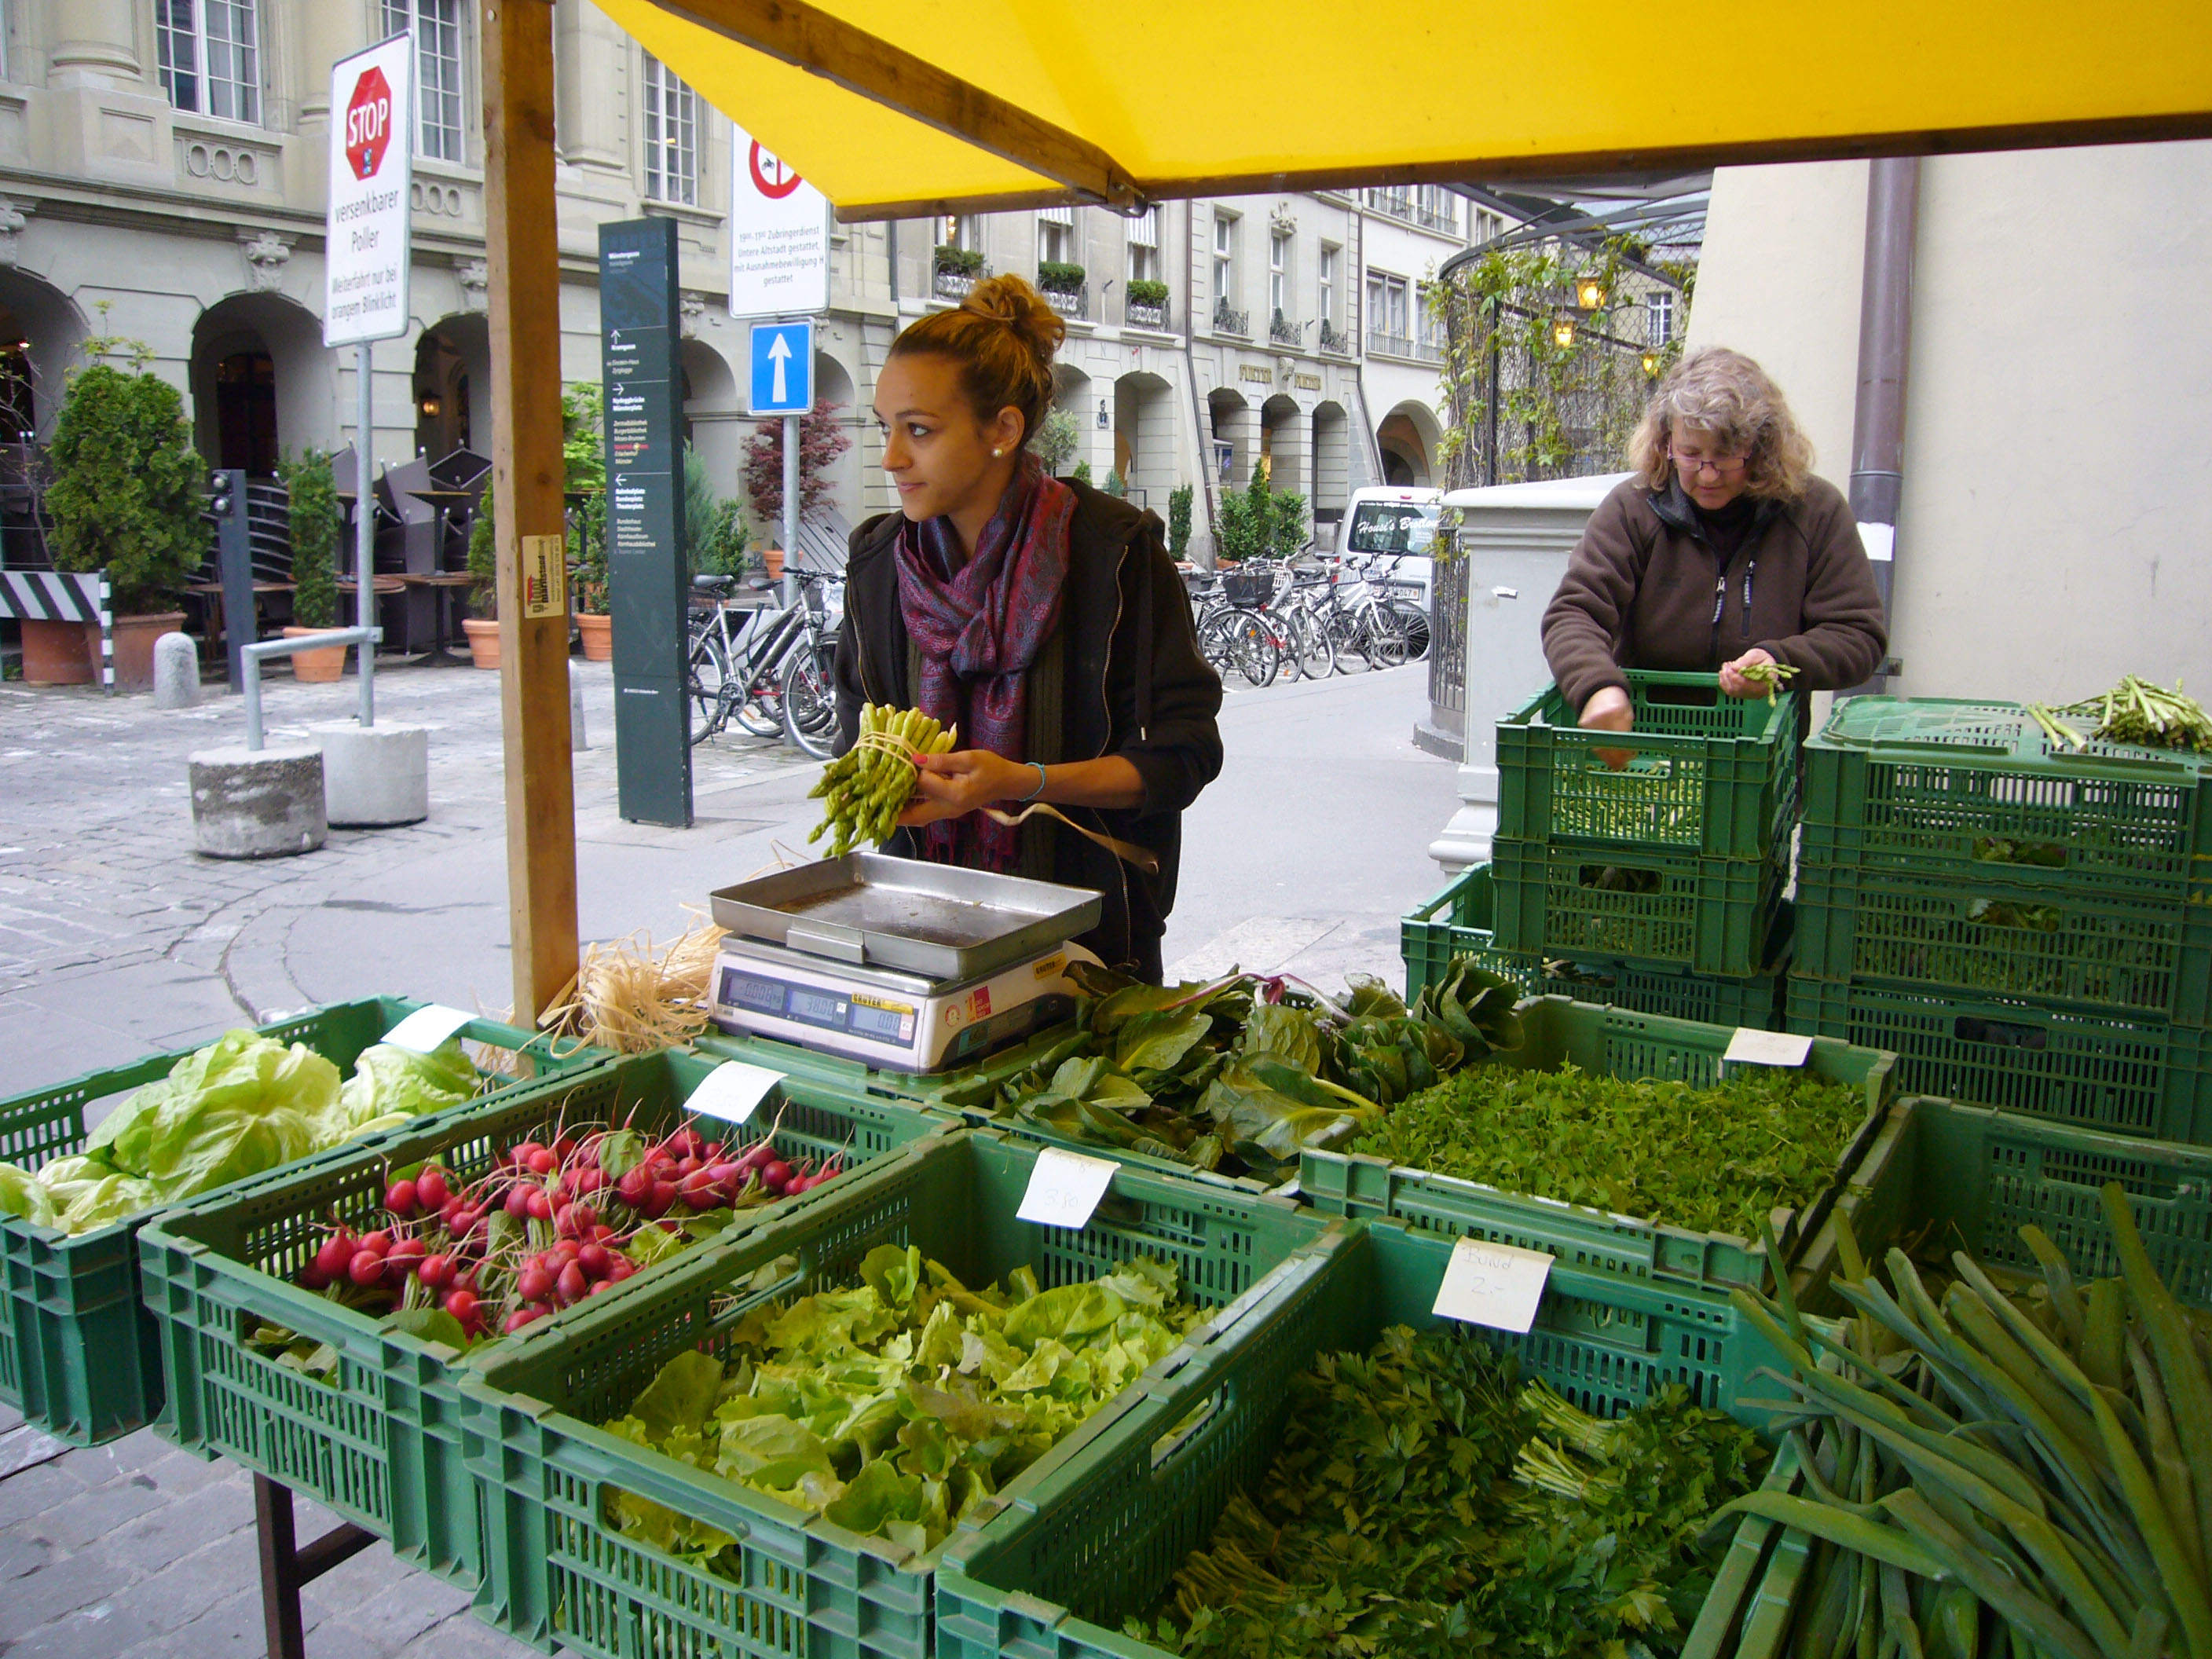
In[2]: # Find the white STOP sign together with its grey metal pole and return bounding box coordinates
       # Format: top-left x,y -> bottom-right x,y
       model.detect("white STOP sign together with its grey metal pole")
324,35 -> 414,726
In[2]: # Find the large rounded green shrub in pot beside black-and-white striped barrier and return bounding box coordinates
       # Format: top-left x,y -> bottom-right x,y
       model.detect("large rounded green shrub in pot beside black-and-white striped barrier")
43,358 -> 208,690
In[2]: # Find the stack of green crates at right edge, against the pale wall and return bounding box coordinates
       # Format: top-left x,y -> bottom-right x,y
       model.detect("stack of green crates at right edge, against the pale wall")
1785,697 -> 2212,1141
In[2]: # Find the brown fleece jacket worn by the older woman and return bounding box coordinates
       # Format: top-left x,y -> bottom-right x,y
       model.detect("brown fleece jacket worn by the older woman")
1544,478 -> 1889,710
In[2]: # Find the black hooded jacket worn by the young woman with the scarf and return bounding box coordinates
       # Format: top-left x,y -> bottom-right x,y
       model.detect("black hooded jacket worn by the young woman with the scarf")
836,482 -> 1221,982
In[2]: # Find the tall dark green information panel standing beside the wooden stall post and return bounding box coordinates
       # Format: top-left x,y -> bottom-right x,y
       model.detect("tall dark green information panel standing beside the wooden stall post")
599,219 -> 690,827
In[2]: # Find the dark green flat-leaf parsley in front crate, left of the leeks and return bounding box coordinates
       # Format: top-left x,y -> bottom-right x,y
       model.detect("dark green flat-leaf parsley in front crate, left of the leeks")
1126,1328 -> 1765,1659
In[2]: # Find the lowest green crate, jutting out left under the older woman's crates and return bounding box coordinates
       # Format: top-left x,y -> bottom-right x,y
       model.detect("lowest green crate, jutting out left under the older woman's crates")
1398,865 -> 1792,1031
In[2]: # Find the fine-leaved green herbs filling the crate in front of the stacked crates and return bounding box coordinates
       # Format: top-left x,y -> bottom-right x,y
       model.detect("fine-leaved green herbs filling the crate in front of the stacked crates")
1352,1066 -> 1867,1239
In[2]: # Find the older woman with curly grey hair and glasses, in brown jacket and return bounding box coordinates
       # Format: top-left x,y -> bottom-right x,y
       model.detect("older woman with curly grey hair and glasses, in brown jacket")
1544,345 -> 1889,732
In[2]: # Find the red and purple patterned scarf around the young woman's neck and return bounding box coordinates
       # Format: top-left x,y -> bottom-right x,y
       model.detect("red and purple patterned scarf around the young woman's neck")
898,456 -> 1075,872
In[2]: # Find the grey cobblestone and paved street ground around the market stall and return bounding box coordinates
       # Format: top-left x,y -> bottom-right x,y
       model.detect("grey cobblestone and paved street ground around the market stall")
0,664 -> 1456,1659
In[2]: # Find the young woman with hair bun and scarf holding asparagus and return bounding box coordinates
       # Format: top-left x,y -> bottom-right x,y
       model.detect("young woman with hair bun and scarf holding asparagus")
836,276 -> 1221,980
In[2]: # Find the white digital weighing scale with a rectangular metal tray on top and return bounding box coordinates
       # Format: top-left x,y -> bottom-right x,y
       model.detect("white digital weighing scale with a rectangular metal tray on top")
712,851 -> 1101,1073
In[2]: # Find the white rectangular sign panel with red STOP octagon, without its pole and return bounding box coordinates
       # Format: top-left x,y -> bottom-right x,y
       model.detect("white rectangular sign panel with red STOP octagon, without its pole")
323,35 -> 414,345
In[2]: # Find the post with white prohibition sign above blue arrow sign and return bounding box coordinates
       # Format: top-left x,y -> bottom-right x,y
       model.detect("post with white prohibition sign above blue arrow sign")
730,128 -> 830,602
